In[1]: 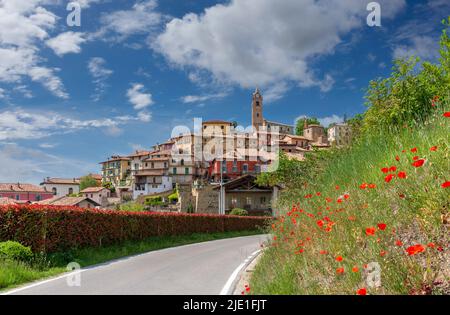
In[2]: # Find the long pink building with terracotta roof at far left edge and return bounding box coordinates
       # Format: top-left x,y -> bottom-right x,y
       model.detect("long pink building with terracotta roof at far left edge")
0,183 -> 53,202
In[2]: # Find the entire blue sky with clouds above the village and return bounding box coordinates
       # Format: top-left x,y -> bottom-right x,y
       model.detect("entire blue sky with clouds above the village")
0,0 -> 450,183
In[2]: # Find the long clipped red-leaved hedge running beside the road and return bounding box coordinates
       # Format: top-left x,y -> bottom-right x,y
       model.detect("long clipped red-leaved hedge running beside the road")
0,205 -> 267,253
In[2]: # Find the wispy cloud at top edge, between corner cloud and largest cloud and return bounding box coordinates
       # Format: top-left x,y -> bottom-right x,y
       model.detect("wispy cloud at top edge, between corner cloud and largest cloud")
93,0 -> 163,42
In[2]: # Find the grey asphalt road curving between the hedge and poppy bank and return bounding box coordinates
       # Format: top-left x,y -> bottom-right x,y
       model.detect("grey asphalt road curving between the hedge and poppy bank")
7,235 -> 267,295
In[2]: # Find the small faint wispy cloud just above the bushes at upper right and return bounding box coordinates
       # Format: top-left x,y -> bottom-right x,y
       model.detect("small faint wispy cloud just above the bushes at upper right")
393,36 -> 439,60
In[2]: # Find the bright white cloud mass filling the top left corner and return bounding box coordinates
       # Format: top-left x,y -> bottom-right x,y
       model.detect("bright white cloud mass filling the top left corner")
0,0 -> 68,98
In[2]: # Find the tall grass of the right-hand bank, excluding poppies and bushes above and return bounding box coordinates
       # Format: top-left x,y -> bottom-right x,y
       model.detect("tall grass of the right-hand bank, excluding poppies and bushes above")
251,108 -> 450,294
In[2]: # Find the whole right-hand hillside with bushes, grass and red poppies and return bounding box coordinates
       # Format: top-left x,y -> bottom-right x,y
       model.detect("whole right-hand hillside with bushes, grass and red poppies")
250,18 -> 450,295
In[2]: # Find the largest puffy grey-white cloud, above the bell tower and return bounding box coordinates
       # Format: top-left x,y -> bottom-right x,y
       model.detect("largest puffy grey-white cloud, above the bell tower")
152,0 -> 405,97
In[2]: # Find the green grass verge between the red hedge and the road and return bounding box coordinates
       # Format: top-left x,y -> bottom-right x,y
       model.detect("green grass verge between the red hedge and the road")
0,231 -> 260,290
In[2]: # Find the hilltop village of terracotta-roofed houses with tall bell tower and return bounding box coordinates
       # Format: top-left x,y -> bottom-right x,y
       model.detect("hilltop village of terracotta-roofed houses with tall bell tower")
0,88 -> 352,215
